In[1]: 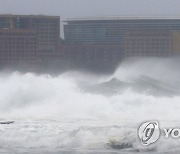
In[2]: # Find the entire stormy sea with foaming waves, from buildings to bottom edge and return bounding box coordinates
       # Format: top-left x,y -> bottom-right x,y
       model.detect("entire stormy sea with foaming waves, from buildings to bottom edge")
0,57 -> 180,154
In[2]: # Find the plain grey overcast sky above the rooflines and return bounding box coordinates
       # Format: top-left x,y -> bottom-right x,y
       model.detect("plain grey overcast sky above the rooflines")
0,0 -> 180,18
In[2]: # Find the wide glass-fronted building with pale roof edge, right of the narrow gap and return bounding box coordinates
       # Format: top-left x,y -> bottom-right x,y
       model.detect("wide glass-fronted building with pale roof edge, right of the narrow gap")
64,17 -> 180,57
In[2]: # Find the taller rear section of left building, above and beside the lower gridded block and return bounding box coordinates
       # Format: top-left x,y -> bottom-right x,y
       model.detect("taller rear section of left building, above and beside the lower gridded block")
0,15 -> 60,52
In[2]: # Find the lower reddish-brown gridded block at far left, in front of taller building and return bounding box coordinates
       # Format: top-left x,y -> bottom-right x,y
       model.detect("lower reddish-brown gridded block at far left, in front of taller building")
0,29 -> 38,68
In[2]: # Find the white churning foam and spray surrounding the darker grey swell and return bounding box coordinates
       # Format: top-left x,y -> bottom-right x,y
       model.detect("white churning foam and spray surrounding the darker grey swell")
0,58 -> 180,151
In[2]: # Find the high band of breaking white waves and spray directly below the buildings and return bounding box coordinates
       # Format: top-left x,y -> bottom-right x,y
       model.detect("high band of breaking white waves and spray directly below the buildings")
0,56 -> 180,120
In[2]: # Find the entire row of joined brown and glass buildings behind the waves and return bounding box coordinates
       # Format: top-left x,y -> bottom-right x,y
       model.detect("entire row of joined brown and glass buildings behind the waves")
0,15 -> 180,70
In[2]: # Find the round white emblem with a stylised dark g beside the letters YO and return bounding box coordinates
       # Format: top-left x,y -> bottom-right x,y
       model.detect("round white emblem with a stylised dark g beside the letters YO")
138,121 -> 161,145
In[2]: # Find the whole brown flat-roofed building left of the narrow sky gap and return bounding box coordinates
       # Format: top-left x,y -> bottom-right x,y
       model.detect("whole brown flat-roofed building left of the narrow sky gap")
0,15 -> 60,69
